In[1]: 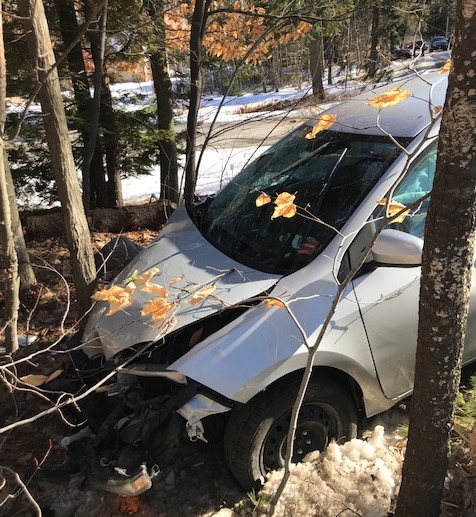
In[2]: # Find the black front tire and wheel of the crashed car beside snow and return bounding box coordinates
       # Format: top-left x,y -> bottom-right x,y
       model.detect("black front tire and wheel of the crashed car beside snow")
224,377 -> 357,490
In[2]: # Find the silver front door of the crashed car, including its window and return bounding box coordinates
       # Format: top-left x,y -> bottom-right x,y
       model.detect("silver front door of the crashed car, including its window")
354,143 -> 476,398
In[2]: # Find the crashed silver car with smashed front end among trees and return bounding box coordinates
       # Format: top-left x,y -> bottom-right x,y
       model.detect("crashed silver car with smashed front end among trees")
73,74 -> 468,494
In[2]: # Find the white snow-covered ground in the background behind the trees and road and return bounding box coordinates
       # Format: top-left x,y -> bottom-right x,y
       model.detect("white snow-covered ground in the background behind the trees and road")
7,56 -> 446,208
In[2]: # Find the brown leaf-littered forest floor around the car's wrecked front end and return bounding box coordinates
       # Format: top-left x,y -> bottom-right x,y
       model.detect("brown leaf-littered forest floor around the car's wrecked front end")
0,230 -> 476,517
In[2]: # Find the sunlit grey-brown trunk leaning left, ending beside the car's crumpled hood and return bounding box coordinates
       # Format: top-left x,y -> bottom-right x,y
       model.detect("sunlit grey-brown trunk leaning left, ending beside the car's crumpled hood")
19,0 -> 96,315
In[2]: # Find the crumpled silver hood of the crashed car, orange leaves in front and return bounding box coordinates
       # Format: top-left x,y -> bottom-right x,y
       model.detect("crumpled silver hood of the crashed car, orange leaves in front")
83,207 -> 281,359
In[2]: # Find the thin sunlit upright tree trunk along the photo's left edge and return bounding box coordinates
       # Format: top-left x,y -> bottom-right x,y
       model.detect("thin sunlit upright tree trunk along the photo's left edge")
0,0 -> 20,354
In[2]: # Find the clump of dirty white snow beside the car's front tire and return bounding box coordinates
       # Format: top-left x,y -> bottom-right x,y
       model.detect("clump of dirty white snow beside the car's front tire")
260,426 -> 403,517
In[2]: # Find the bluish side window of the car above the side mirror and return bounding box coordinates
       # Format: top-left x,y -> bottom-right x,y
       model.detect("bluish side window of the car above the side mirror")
392,144 -> 437,238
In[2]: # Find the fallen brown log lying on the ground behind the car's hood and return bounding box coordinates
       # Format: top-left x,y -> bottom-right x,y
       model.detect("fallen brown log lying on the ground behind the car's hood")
21,200 -> 175,239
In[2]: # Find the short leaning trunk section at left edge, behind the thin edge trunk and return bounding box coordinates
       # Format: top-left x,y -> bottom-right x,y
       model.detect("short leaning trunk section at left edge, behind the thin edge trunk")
0,152 -> 36,289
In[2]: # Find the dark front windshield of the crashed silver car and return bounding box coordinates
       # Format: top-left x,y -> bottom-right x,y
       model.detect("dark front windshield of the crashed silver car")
194,125 -> 408,274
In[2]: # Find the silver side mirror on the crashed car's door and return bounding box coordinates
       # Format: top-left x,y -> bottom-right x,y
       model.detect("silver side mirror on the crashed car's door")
372,228 -> 423,266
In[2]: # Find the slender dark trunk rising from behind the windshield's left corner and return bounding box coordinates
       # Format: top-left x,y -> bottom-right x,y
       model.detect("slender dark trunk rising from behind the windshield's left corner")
184,0 -> 211,206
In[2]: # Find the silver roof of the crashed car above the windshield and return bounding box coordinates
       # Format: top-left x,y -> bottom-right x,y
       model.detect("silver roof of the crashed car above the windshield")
318,73 -> 448,138
